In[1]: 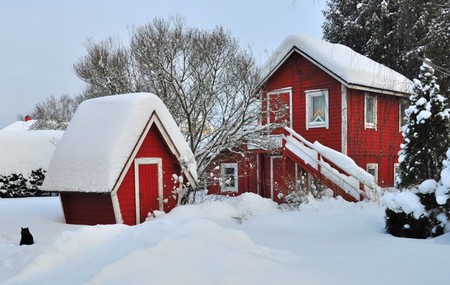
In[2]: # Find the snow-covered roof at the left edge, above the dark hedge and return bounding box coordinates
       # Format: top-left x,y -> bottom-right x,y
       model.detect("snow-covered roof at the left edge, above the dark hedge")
0,121 -> 64,177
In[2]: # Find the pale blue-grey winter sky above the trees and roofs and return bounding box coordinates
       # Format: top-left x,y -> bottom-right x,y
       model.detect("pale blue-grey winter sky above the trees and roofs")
0,0 -> 326,129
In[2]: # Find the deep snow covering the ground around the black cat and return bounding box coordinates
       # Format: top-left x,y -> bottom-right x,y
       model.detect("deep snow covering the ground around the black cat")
0,194 -> 450,285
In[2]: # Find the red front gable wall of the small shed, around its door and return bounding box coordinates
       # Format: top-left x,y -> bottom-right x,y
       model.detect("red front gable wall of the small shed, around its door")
117,126 -> 181,225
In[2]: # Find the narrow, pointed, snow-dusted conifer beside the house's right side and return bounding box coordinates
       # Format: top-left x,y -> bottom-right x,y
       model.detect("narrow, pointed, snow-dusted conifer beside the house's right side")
398,59 -> 450,187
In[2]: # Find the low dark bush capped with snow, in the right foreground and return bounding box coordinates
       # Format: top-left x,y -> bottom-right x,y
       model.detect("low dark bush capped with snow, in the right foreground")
381,149 -> 450,238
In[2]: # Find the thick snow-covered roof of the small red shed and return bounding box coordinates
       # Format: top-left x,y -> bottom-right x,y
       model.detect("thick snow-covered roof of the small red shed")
42,93 -> 197,193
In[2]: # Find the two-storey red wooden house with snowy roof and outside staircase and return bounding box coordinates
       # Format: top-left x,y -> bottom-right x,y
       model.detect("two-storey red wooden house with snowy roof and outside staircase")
209,36 -> 411,201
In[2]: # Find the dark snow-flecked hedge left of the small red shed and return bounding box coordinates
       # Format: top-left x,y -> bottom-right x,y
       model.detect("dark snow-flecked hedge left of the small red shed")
0,168 -> 50,198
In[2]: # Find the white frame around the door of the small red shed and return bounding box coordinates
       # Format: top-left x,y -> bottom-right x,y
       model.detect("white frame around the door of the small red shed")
134,157 -> 164,224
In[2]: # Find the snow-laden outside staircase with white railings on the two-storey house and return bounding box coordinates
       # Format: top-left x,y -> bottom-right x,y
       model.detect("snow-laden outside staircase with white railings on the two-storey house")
283,128 -> 382,202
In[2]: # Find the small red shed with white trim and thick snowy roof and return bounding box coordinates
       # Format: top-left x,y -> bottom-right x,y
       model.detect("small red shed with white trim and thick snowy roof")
42,93 -> 197,225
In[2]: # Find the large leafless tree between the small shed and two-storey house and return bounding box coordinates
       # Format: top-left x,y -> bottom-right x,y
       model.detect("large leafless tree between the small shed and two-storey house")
75,17 -> 272,174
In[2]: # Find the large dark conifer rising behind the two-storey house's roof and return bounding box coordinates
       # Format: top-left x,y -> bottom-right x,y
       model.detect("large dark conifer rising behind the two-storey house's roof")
322,0 -> 450,92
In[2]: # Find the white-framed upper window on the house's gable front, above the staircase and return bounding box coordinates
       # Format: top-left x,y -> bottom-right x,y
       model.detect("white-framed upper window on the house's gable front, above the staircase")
305,90 -> 328,129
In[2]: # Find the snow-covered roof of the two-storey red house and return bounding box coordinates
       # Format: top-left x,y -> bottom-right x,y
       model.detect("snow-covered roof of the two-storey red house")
261,35 -> 412,94
